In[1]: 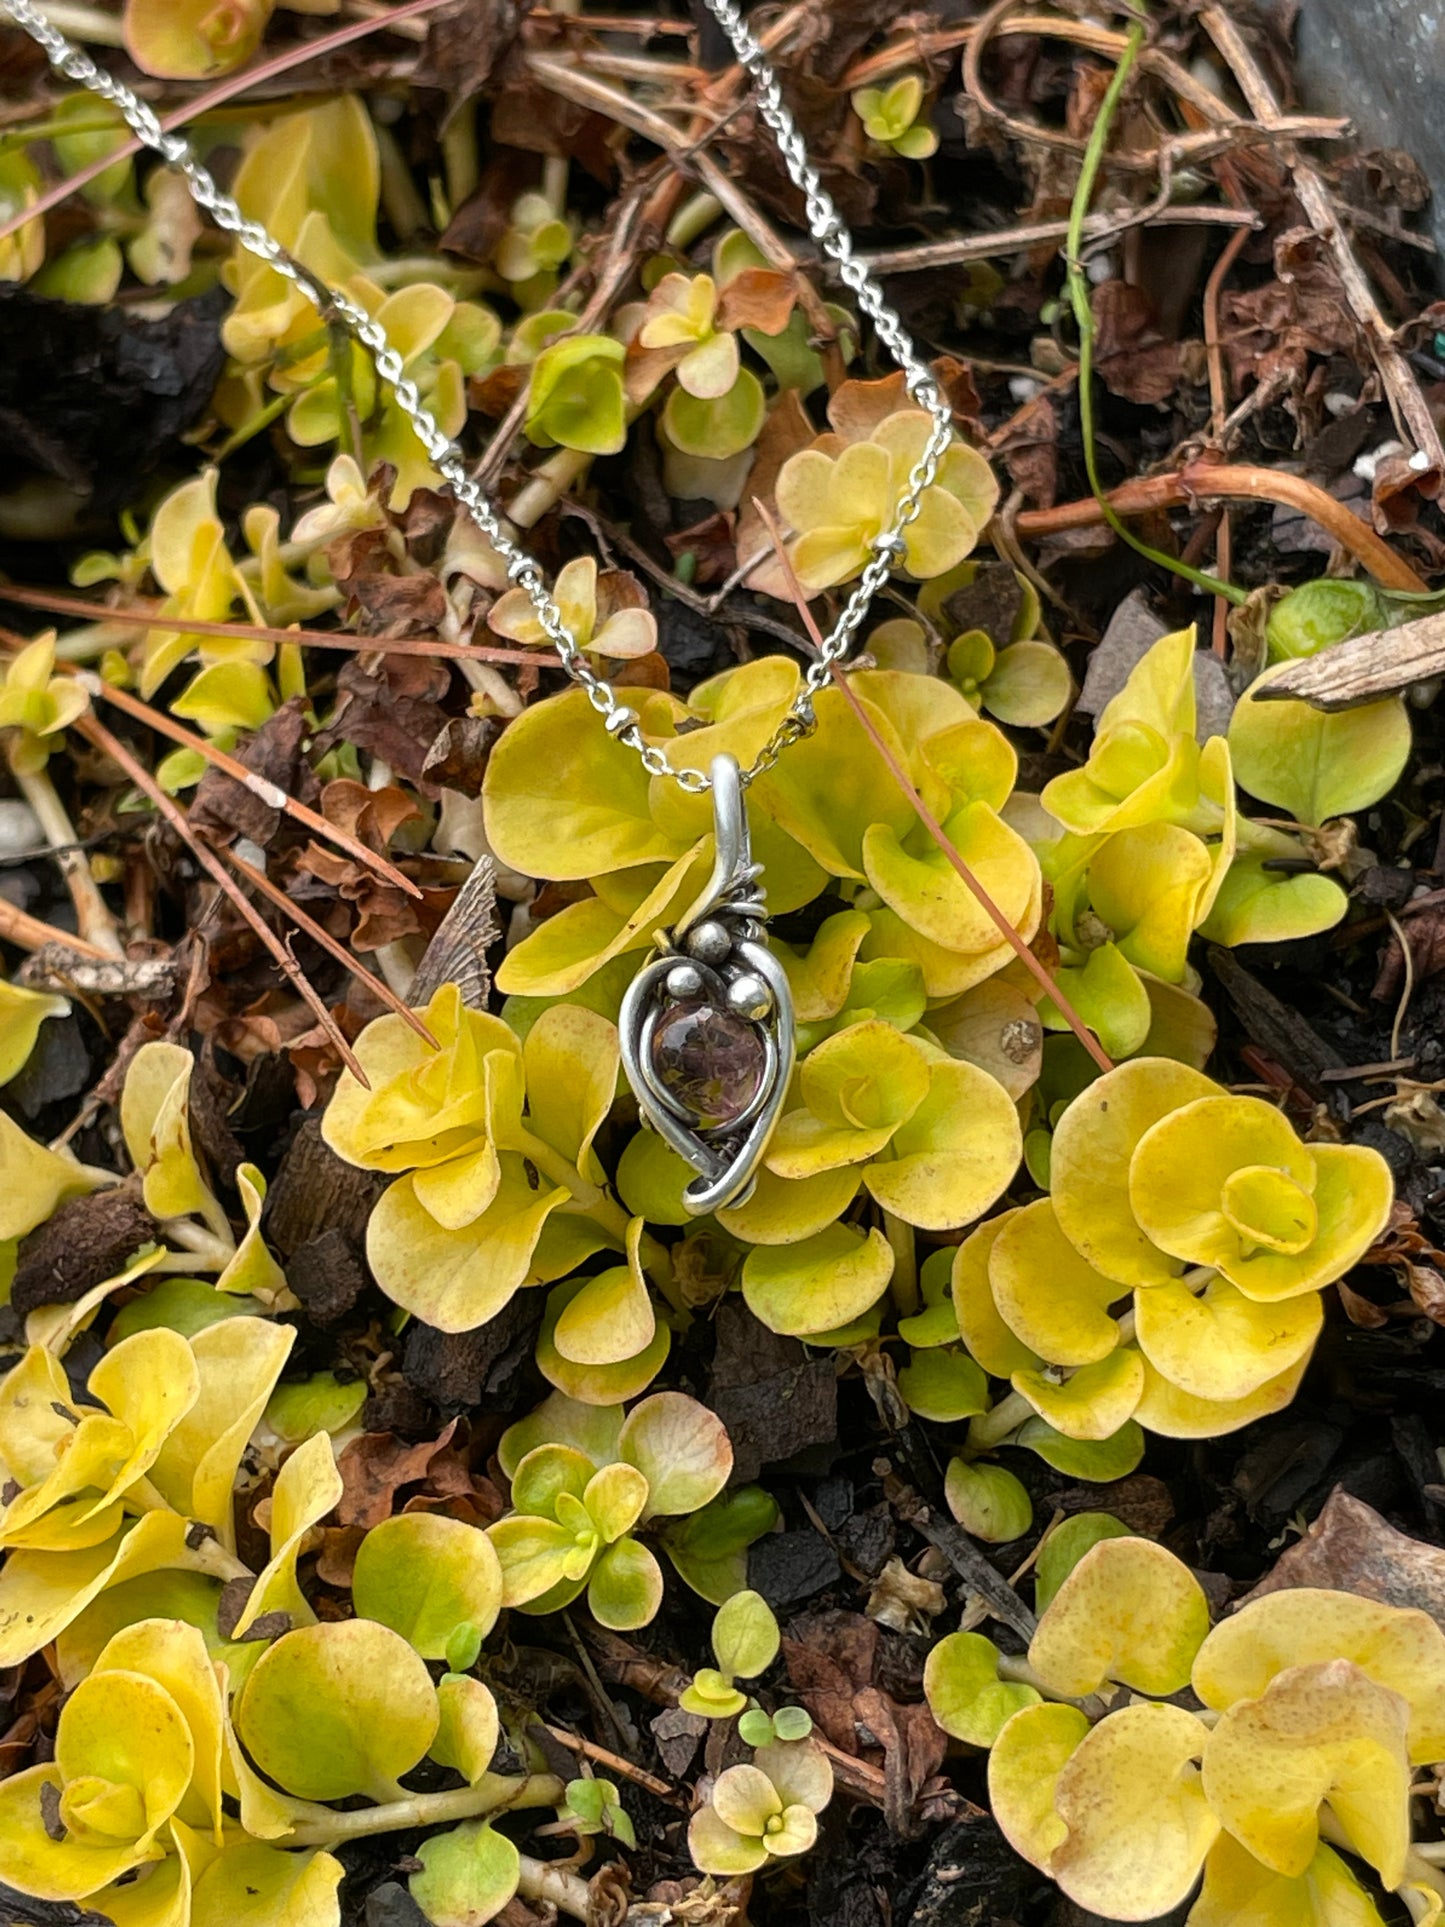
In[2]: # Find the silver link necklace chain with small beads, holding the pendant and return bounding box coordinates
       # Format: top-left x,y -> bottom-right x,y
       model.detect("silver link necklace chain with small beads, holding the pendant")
0,0 -> 952,792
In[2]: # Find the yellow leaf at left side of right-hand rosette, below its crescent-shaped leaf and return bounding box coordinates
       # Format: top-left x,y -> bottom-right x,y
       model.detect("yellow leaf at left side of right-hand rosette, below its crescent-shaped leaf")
994,1199 -> 1129,1364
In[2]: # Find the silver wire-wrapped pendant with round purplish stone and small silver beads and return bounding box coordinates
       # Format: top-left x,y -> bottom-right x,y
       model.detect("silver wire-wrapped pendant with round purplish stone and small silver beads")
618,755 -> 794,1218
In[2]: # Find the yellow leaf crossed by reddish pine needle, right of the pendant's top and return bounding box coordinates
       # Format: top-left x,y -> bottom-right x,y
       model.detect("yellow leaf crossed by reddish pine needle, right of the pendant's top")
863,804 -> 1038,956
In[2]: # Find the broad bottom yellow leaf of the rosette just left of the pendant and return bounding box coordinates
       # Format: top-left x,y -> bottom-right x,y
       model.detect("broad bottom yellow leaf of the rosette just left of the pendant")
366,1152 -> 568,1332
